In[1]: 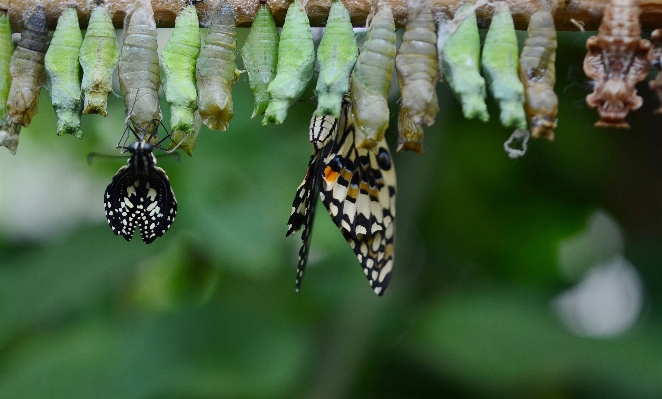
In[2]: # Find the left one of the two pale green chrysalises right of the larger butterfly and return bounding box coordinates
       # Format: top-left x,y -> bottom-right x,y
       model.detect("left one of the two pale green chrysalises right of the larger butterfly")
444,3 -> 490,122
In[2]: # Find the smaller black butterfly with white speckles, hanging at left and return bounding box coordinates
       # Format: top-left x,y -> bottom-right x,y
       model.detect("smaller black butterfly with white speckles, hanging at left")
104,123 -> 177,244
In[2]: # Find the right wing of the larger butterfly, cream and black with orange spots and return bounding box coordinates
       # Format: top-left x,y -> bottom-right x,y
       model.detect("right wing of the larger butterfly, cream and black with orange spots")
319,101 -> 396,295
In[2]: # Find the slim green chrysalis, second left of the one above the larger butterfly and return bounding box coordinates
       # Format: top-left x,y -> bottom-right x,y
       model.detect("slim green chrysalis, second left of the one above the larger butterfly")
241,3 -> 278,118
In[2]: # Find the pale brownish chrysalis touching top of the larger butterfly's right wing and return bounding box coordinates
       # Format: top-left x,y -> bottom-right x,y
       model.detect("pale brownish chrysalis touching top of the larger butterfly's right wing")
349,2 -> 395,149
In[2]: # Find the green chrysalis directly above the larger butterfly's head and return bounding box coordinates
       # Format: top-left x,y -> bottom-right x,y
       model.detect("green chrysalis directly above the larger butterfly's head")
315,0 -> 359,118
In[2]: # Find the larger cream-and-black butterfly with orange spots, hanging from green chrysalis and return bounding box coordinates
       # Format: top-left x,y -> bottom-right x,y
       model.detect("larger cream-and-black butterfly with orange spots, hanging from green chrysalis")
287,97 -> 396,296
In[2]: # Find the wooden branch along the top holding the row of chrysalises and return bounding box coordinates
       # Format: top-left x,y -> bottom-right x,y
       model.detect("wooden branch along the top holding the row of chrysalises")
0,0 -> 662,32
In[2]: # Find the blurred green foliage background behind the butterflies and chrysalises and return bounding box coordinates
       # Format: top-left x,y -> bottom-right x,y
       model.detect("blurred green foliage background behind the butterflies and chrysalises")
0,28 -> 662,399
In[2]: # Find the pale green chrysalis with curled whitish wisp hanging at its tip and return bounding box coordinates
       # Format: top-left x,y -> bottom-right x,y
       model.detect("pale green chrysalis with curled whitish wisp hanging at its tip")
481,1 -> 526,129
